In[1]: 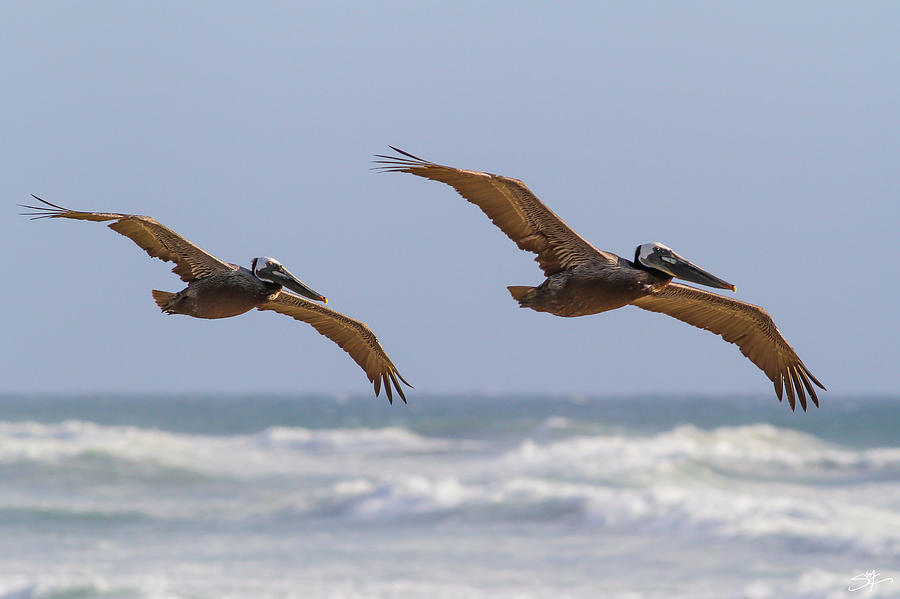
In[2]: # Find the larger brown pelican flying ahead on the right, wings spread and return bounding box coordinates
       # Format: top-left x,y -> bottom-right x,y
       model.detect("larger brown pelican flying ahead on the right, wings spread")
376,146 -> 825,411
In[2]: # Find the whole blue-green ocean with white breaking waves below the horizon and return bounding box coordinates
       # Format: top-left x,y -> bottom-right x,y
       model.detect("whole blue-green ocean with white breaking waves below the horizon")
0,393 -> 900,599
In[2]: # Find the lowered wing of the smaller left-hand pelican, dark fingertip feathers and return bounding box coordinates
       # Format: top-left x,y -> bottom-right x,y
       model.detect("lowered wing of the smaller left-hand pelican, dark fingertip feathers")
258,291 -> 412,403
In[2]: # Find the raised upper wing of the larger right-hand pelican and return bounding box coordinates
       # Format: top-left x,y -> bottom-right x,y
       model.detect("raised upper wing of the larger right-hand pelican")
375,146 -> 617,276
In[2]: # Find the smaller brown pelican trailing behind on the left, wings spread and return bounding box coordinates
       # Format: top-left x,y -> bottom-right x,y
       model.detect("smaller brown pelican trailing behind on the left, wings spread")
22,196 -> 411,403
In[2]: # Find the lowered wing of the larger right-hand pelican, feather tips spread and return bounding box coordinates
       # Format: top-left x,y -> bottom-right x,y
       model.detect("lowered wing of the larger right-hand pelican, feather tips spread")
632,283 -> 825,411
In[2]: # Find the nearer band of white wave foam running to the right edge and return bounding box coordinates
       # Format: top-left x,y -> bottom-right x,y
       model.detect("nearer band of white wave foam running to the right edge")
304,468 -> 900,556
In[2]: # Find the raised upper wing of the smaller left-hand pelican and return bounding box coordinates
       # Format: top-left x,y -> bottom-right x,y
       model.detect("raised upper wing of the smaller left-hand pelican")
22,195 -> 234,282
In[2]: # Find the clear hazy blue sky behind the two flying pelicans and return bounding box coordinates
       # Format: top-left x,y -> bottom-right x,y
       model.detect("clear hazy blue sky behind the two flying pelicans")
0,2 -> 900,401
